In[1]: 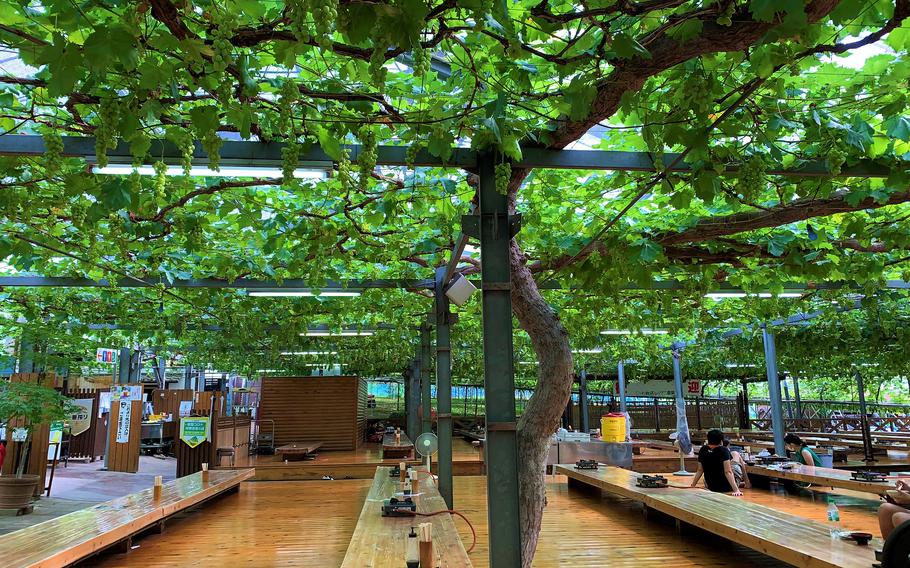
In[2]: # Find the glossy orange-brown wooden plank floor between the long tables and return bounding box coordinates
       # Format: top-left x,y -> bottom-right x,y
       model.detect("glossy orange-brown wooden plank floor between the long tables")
88,470 -> 878,568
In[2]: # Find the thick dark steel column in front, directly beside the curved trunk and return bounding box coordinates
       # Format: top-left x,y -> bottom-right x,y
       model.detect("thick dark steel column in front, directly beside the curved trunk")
477,153 -> 521,568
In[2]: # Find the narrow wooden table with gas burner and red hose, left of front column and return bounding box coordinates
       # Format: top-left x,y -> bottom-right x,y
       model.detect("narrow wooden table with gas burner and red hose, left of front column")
341,467 -> 471,568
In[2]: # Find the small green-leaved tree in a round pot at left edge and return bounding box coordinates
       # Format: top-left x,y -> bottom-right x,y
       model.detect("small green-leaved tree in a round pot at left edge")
0,382 -> 79,509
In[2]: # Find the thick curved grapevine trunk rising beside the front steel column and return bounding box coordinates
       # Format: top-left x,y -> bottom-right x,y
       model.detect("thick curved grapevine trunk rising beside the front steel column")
510,240 -> 572,568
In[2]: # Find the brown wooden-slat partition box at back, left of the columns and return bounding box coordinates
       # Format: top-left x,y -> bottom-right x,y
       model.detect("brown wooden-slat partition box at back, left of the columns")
259,377 -> 367,450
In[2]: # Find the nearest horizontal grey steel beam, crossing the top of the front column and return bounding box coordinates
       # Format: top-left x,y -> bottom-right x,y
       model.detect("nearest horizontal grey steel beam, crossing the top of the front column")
0,135 -> 908,178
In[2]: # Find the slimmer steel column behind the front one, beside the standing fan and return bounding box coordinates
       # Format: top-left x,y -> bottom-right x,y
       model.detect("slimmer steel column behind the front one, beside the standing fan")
436,266 -> 452,509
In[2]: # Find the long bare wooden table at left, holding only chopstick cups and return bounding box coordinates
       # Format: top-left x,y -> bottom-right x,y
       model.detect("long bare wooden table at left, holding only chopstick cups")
0,469 -> 255,568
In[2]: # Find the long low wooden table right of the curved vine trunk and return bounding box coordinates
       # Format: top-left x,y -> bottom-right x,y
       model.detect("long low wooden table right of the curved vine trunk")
556,465 -> 880,568
